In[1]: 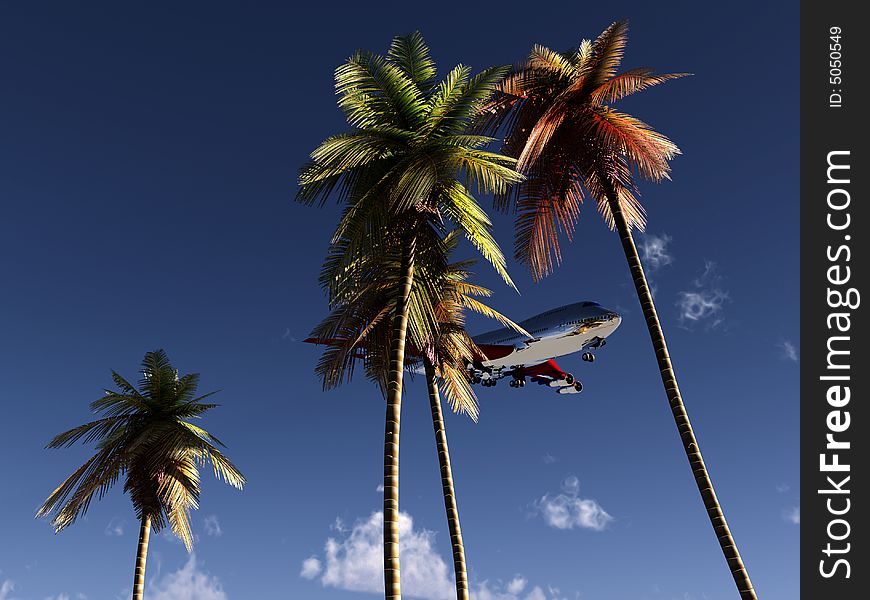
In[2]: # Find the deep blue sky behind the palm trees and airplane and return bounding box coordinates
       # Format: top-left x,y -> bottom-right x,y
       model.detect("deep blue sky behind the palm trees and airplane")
0,2 -> 799,600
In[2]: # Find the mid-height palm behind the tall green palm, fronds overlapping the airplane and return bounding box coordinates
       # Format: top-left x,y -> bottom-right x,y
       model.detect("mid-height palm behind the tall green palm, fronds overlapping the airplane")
312,231 -> 528,600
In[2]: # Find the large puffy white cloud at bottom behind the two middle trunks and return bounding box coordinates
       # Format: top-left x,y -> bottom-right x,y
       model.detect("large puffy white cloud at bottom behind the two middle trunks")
299,512 -> 576,600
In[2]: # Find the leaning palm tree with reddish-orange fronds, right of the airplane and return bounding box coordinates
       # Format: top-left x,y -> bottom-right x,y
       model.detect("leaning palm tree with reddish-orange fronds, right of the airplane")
485,22 -> 756,599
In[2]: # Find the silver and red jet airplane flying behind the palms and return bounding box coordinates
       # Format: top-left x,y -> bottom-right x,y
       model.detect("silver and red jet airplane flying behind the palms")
305,300 -> 622,394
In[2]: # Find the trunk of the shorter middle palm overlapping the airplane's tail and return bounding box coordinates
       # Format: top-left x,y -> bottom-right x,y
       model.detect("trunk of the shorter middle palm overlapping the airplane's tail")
424,359 -> 468,600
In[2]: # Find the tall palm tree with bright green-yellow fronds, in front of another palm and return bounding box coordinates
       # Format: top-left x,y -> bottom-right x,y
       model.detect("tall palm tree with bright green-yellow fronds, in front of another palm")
297,33 -> 521,599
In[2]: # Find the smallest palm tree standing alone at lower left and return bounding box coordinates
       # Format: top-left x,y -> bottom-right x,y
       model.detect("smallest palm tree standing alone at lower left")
36,350 -> 245,600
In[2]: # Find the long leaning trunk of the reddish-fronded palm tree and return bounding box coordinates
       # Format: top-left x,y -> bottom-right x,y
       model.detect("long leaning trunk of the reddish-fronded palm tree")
609,194 -> 758,600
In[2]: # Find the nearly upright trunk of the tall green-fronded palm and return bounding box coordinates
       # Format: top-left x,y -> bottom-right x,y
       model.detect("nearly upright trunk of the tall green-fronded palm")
384,236 -> 416,600
